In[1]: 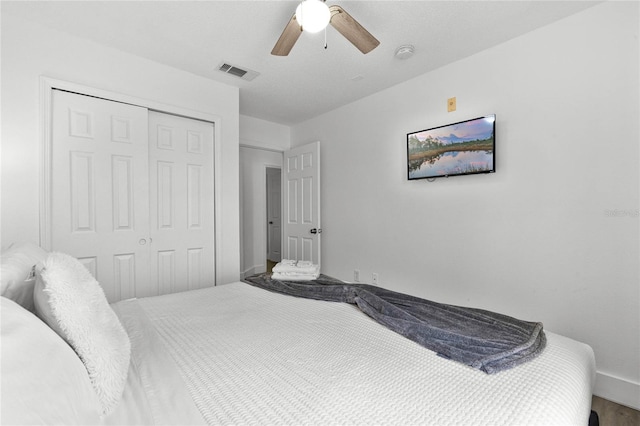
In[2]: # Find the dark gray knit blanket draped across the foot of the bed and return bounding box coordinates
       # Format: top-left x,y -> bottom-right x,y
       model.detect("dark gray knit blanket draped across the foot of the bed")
244,274 -> 546,374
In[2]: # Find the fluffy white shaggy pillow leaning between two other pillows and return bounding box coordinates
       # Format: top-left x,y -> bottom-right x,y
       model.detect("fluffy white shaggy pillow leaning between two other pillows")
34,253 -> 131,414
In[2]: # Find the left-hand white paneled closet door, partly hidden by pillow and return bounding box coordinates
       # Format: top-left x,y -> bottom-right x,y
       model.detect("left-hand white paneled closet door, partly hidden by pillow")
49,90 -> 149,301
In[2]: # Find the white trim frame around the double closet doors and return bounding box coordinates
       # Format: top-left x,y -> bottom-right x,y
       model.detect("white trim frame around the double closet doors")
39,76 -> 223,284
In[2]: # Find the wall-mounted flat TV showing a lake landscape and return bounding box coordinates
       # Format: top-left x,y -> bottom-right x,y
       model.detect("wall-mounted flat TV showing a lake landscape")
407,115 -> 496,180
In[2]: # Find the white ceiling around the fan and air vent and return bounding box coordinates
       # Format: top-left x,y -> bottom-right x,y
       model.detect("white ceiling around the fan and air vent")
1,0 -> 598,125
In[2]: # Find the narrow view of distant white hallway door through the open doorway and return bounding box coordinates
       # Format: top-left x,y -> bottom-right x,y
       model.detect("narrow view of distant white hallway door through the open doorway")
267,167 -> 282,262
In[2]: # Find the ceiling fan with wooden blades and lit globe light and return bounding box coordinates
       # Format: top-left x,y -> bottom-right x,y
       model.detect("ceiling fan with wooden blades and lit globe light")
271,0 -> 380,56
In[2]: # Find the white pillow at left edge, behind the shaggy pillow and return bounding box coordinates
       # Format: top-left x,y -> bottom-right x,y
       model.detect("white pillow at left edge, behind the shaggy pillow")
0,243 -> 47,312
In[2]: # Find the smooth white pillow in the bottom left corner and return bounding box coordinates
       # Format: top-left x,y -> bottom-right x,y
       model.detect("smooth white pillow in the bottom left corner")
0,297 -> 102,425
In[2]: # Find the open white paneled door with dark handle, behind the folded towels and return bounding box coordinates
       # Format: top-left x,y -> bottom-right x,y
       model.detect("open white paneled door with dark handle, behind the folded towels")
283,142 -> 322,265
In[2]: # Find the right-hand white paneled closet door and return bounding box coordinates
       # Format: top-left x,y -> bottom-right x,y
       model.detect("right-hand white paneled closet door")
149,111 -> 215,294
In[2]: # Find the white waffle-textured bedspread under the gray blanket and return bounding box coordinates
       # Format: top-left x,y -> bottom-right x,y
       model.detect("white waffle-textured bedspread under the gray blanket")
110,283 -> 595,425
